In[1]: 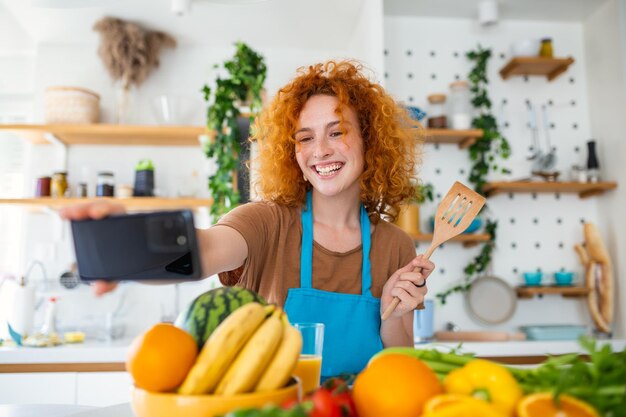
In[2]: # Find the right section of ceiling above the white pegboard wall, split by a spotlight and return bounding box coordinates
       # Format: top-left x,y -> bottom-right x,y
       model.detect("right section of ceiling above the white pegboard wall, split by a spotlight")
384,0 -> 607,22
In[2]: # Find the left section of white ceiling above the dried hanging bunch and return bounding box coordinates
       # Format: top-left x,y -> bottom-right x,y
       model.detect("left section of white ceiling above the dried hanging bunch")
0,0 -> 364,48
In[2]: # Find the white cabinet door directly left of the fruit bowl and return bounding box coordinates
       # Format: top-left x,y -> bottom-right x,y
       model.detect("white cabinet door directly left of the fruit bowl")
76,372 -> 133,407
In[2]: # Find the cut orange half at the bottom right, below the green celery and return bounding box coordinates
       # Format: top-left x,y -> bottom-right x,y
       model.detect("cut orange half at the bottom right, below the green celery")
517,392 -> 598,417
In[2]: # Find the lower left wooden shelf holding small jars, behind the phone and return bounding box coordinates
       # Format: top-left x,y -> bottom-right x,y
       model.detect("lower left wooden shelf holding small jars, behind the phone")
0,197 -> 213,211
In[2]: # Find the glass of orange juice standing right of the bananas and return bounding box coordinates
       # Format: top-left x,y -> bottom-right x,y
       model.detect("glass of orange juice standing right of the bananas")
293,323 -> 324,394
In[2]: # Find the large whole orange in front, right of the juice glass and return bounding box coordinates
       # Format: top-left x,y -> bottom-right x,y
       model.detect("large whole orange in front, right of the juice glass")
352,354 -> 443,417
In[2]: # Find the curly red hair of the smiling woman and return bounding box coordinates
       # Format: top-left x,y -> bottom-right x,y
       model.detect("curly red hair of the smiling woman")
251,61 -> 421,221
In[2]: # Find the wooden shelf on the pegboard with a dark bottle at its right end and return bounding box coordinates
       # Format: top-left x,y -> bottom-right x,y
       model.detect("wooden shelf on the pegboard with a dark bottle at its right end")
483,181 -> 617,198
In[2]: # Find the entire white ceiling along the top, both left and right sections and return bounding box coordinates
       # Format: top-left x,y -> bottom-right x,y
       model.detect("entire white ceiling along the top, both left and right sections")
0,0 -> 607,49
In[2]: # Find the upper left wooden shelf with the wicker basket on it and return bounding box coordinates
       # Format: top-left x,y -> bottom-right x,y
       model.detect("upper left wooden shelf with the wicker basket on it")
0,124 -> 207,146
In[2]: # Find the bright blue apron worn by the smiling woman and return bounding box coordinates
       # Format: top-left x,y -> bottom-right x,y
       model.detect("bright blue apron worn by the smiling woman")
285,191 -> 383,379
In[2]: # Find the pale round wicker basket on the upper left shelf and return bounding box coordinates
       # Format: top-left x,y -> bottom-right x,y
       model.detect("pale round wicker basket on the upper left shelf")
44,87 -> 100,124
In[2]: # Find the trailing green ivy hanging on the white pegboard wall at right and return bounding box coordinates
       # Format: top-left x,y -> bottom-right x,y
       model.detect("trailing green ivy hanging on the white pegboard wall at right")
436,45 -> 511,304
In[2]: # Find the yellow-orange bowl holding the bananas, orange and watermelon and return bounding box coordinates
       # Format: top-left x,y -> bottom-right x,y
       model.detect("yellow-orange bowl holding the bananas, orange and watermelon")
131,380 -> 298,417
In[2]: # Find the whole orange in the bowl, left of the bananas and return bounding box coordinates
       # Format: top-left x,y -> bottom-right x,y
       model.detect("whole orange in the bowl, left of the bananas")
126,323 -> 198,392
